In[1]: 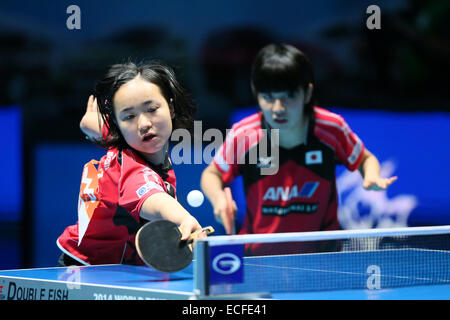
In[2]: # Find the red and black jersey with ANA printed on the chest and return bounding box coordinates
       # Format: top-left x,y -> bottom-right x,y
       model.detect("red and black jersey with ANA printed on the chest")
214,107 -> 364,253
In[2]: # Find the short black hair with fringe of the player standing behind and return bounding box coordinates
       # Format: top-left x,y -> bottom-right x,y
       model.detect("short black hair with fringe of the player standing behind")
251,44 -> 315,115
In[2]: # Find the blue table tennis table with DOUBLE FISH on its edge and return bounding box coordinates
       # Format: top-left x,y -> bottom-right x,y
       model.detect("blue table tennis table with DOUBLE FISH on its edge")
0,249 -> 450,300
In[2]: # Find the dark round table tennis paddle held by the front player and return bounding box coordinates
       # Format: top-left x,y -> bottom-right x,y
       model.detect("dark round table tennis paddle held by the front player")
136,220 -> 214,272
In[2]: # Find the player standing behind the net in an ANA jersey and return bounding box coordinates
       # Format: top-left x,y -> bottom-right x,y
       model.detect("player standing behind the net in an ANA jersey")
201,44 -> 397,254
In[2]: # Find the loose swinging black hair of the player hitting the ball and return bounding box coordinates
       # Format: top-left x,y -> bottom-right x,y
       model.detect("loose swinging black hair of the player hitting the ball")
94,60 -> 196,149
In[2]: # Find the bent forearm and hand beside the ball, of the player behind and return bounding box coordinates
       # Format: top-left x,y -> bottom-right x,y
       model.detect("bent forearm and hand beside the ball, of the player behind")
200,162 -> 237,234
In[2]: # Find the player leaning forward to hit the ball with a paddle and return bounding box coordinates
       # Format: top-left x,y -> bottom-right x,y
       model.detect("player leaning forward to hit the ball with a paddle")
57,62 -> 206,266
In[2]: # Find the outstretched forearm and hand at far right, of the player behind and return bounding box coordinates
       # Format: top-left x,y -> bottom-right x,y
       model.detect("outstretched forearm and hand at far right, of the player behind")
359,149 -> 397,190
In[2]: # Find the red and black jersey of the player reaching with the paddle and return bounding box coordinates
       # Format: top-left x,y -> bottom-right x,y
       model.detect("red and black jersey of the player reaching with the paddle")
57,148 -> 176,265
